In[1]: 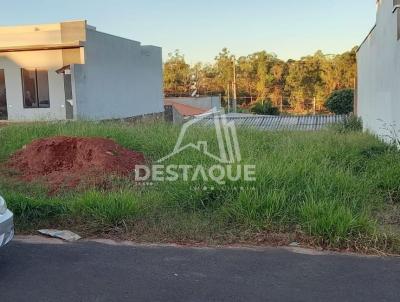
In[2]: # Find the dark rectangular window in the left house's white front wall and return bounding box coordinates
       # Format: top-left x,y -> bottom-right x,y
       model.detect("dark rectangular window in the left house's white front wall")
22,69 -> 50,108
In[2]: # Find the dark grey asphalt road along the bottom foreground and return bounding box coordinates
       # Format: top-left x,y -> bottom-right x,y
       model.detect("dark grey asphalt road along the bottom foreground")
0,238 -> 400,302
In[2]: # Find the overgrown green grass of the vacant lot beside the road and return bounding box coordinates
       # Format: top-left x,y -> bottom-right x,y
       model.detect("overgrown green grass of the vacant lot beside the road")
0,122 -> 400,253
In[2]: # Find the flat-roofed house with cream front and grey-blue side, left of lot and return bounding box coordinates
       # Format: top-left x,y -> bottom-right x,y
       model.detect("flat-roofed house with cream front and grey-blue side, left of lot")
0,21 -> 164,121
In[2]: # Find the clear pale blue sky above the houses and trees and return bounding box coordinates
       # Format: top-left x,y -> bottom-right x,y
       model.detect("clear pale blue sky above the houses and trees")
0,0 -> 376,63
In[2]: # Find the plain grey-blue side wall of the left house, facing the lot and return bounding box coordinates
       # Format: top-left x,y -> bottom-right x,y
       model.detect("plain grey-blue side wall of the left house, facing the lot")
74,29 -> 164,119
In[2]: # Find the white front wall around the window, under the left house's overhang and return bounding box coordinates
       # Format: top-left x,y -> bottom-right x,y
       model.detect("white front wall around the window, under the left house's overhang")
0,50 -> 66,121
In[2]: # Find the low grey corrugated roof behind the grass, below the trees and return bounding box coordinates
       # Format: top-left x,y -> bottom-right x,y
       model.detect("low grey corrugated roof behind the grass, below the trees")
192,114 -> 347,131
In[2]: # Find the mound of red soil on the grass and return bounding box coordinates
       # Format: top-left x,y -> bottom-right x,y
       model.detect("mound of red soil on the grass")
8,137 -> 145,192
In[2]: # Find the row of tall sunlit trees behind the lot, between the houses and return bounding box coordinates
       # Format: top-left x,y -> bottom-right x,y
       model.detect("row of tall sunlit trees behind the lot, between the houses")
164,48 -> 357,113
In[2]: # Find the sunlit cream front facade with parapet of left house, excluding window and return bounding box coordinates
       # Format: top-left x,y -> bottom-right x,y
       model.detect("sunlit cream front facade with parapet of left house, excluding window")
0,21 -> 87,121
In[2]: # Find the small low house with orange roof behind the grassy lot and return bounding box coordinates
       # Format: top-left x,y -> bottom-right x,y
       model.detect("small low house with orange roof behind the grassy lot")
164,96 -> 221,123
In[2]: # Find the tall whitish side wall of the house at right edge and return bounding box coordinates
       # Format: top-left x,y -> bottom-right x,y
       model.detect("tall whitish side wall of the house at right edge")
355,0 -> 400,137
